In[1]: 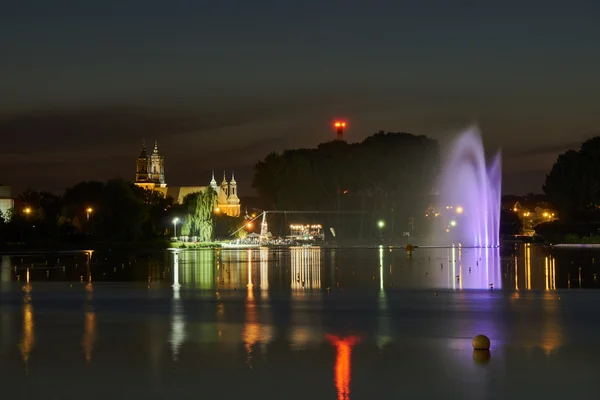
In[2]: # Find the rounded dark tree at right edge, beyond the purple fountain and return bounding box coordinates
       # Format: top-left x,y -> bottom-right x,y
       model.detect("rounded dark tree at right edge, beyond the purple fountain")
543,137 -> 600,219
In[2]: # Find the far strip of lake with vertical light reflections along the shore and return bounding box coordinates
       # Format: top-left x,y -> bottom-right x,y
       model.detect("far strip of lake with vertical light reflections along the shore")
0,244 -> 600,291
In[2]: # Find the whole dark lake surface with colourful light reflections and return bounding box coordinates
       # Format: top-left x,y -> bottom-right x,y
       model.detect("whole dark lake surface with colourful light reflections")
0,245 -> 600,400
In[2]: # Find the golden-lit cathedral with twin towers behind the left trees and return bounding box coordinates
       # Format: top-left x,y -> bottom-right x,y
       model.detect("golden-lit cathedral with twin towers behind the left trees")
135,141 -> 240,217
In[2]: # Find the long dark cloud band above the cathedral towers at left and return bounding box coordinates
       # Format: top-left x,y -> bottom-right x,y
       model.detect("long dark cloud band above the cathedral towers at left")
0,104 -> 259,153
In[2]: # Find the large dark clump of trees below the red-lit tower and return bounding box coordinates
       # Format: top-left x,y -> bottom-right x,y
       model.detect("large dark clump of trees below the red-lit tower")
253,131 -> 440,238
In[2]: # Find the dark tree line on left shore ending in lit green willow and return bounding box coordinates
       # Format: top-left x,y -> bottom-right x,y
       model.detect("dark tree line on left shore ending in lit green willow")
0,179 -> 238,247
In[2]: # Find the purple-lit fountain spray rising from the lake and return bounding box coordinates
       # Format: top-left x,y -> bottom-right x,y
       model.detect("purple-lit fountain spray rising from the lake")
439,128 -> 502,247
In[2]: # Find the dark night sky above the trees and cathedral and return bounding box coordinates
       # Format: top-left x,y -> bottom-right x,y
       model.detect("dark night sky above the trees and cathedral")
0,0 -> 600,195
